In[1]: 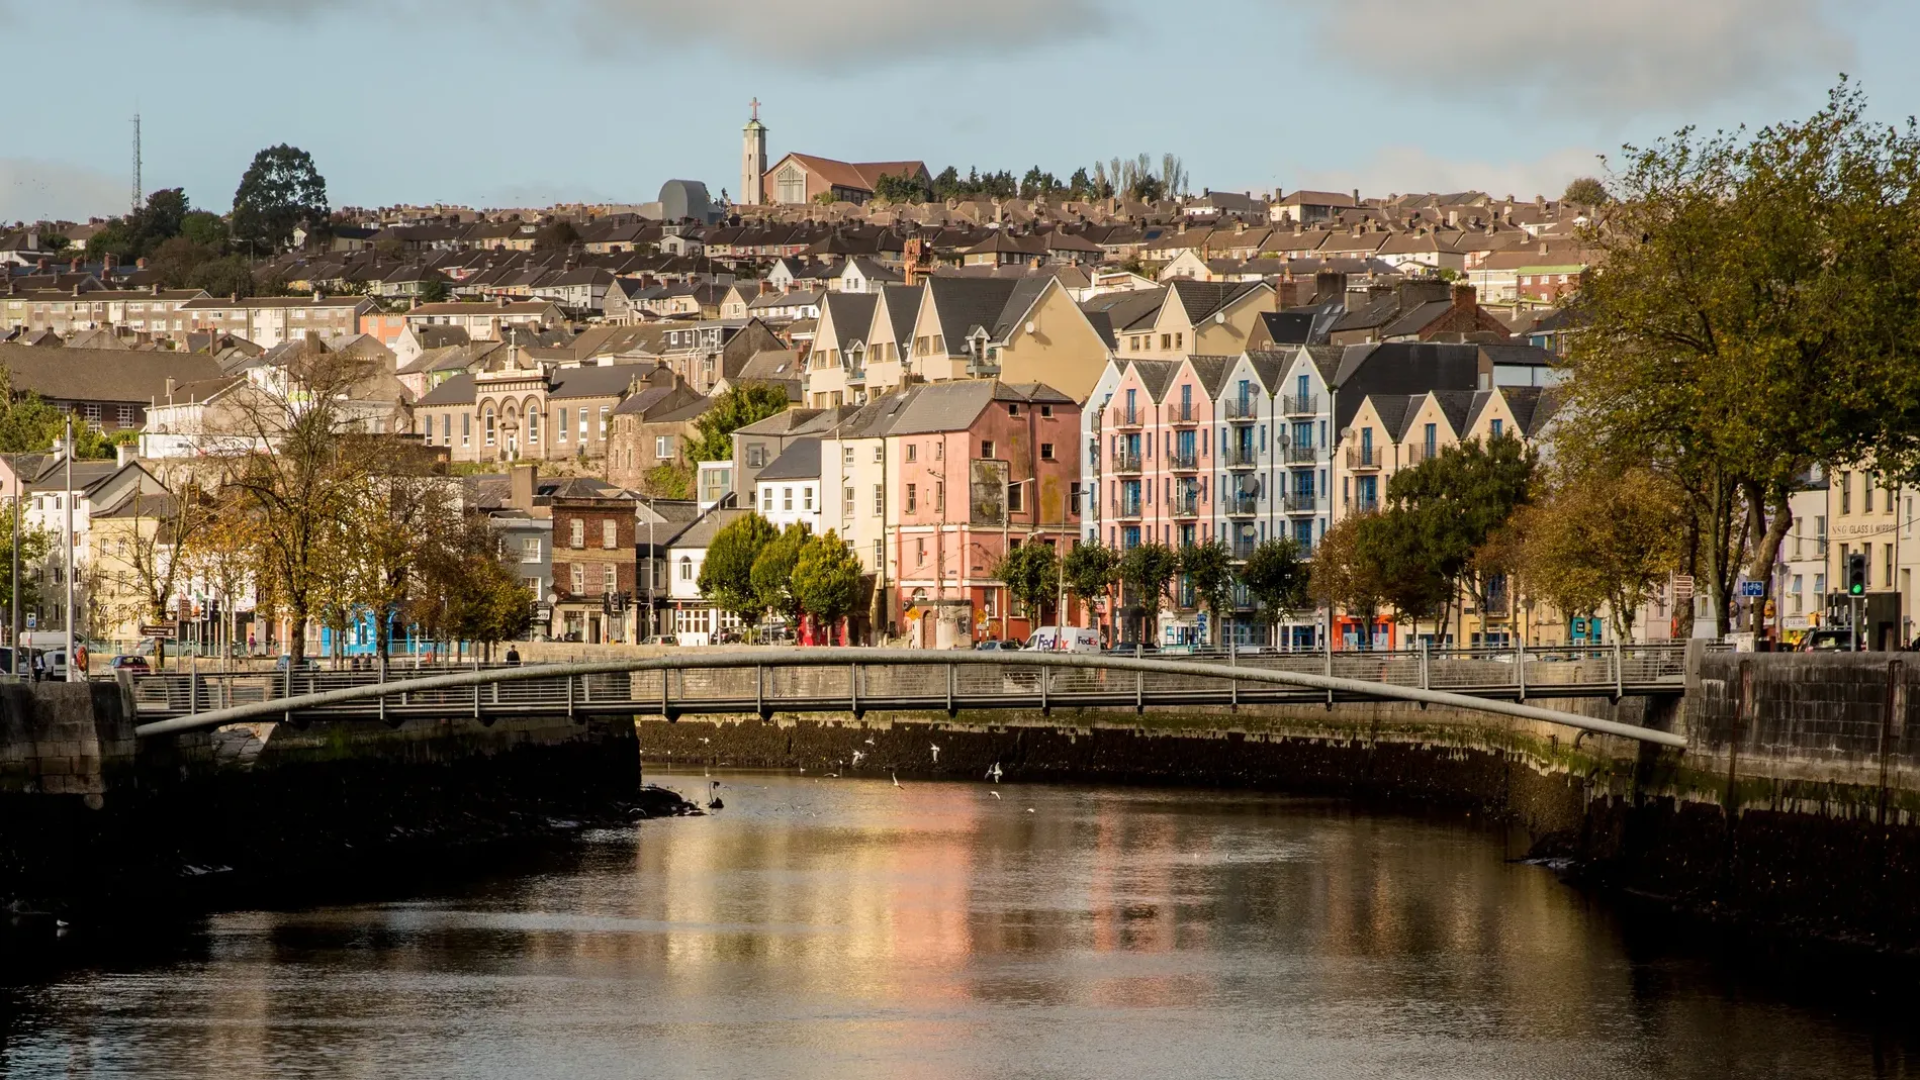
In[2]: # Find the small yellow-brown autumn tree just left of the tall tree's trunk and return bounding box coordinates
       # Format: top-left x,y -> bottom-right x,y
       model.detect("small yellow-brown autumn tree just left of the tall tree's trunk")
1519,467 -> 1688,642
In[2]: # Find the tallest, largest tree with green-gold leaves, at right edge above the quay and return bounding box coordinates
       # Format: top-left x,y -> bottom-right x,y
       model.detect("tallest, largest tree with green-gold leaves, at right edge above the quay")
1557,81 -> 1920,632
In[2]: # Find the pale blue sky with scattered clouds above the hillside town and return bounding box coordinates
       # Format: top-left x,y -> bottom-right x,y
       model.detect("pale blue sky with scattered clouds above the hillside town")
0,0 -> 1920,223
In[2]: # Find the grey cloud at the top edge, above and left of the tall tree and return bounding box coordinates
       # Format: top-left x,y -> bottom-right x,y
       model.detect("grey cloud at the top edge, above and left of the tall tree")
1325,0 -> 1862,117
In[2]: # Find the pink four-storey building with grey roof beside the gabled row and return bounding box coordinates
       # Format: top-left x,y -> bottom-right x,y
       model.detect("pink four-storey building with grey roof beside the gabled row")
879,380 -> 1081,648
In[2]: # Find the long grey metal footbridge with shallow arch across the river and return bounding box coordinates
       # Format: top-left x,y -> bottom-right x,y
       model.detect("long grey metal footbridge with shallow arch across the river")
132,646 -> 1686,748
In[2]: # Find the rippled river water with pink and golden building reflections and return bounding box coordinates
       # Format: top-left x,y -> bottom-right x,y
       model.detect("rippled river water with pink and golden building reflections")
0,774 -> 1916,1080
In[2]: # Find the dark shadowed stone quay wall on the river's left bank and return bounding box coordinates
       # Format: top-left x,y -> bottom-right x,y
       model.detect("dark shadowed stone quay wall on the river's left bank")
0,682 -> 680,920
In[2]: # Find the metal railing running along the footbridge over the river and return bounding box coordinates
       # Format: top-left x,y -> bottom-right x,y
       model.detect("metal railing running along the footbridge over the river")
132,644 -> 1686,715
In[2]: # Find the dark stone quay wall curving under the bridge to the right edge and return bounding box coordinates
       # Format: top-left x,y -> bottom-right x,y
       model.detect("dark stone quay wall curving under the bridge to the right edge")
639,653 -> 1920,951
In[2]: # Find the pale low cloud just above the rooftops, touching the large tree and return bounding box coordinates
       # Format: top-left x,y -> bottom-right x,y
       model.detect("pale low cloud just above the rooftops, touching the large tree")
1286,146 -> 1603,200
